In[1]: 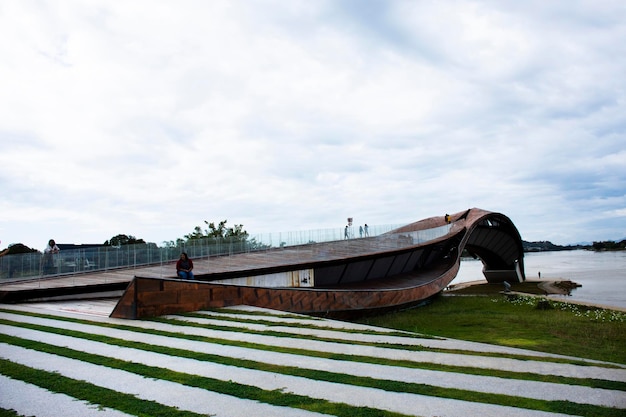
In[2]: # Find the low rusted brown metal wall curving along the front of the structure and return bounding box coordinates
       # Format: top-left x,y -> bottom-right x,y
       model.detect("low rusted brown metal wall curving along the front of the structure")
111,264 -> 458,319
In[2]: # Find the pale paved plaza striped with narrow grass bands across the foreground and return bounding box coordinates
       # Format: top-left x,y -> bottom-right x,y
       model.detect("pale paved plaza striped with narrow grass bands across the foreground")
0,301 -> 626,417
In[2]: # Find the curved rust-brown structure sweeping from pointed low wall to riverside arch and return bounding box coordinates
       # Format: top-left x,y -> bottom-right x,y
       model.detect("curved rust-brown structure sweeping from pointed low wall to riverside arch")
111,209 -> 525,318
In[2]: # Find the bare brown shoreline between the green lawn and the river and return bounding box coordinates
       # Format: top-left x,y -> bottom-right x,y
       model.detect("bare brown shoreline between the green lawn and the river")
443,278 -> 626,312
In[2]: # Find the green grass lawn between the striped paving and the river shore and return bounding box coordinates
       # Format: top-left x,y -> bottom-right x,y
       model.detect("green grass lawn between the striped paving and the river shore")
358,284 -> 626,364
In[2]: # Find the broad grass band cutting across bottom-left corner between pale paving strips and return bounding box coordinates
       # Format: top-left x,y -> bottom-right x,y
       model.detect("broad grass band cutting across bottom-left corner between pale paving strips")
0,359 -> 206,417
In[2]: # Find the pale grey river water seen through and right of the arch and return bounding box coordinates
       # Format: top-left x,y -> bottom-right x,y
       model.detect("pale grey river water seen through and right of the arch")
452,250 -> 626,308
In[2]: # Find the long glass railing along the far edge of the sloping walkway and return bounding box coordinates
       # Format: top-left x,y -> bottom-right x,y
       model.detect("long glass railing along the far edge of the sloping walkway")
0,225 -> 406,283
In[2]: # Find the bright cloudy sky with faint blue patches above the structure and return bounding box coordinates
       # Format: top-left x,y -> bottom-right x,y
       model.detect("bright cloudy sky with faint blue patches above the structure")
0,0 -> 626,250
